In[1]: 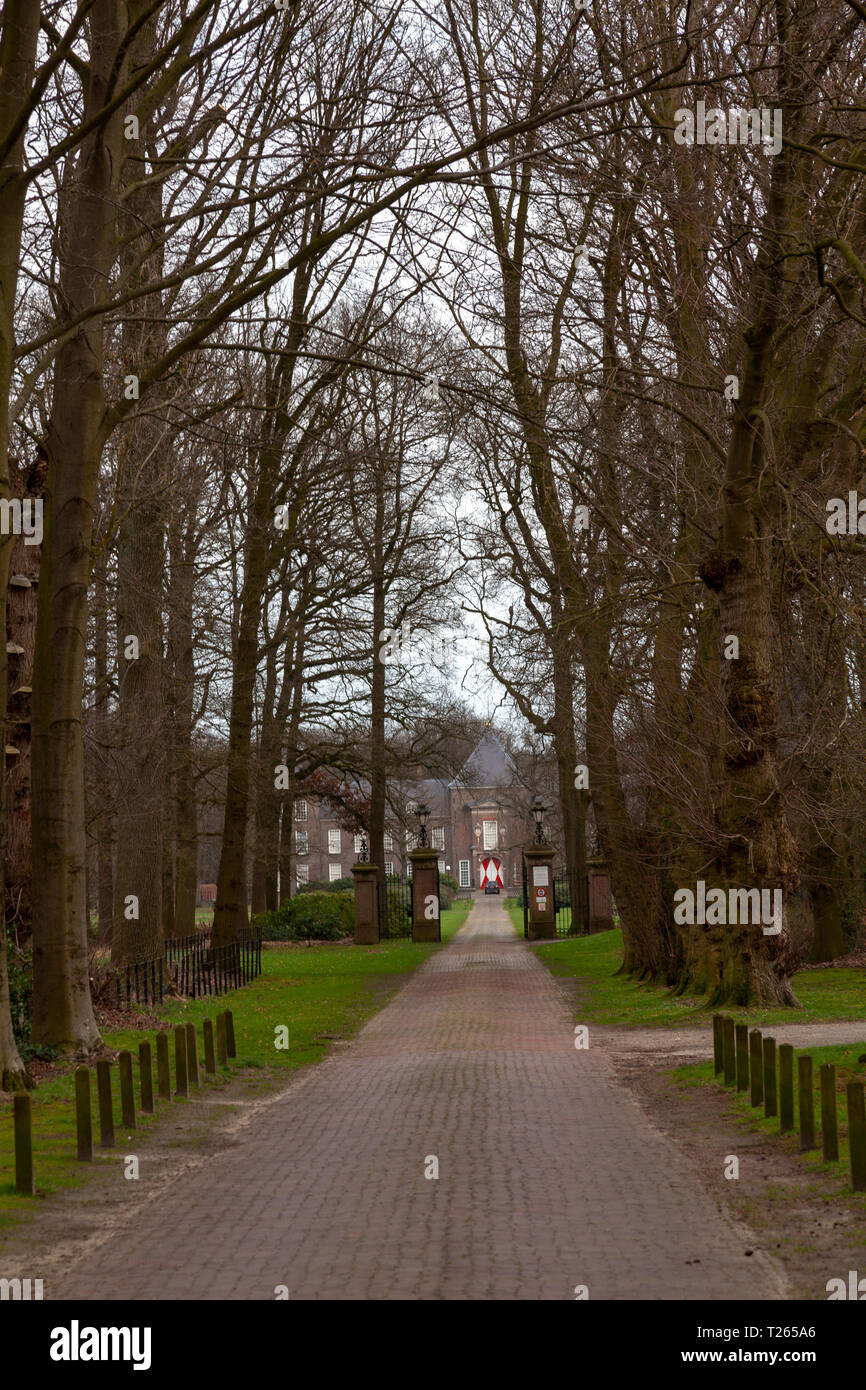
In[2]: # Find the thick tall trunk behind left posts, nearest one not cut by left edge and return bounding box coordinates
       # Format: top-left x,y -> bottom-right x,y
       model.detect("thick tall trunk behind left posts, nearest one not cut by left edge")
33,0 -> 125,1051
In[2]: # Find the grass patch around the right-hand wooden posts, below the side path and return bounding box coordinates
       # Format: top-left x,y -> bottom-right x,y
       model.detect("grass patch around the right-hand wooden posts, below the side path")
669,1045 -> 866,1195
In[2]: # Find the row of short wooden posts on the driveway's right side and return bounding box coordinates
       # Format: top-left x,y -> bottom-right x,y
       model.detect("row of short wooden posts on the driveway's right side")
713,1013 -> 866,1193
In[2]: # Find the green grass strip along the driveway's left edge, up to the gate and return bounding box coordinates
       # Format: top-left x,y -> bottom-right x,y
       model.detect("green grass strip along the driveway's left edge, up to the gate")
0,902 -> 471,1226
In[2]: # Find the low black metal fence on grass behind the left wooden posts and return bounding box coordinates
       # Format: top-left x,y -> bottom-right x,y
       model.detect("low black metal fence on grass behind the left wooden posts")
115,927 -> 264,1008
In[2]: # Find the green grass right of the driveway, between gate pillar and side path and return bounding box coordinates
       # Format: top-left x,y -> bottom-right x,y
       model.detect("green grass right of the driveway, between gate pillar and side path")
528,928 -> 866,1033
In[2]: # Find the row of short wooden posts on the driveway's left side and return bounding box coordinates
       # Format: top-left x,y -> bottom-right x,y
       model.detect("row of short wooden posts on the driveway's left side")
13,1009 -> 238,1197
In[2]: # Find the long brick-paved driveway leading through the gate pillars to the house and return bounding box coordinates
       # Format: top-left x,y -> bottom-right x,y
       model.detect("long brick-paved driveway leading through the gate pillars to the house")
52,898 -> 784,1300
